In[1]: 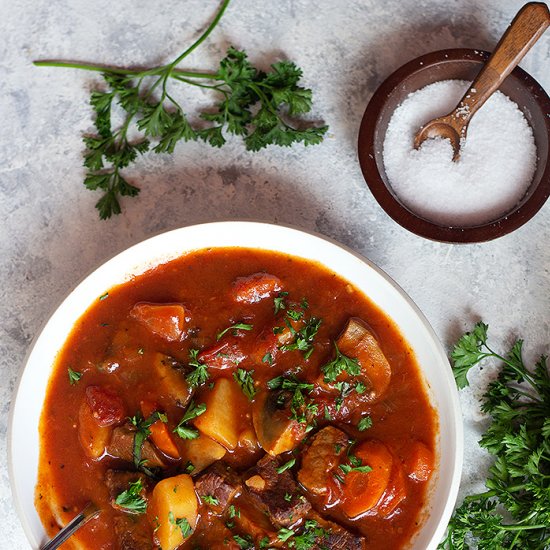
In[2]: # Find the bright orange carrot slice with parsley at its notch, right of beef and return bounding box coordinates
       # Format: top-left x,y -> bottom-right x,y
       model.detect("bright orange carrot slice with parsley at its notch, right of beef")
342,440 -> 393,518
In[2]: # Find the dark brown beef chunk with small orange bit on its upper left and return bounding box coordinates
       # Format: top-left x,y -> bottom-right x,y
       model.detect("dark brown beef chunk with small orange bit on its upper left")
245,455 -> 311,528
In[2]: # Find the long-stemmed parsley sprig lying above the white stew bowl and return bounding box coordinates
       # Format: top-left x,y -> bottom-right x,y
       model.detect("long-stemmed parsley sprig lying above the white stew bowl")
35,0 -> 328,219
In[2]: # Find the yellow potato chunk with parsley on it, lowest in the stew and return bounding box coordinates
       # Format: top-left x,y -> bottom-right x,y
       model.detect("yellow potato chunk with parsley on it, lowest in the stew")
147,474 -> 199,550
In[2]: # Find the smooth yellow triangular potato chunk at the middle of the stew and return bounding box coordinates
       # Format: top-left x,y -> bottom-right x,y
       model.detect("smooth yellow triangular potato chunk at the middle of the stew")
193,378 -> 241,450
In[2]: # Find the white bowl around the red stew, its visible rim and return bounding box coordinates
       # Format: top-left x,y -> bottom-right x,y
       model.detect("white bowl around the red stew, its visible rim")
8,221 -> 463,550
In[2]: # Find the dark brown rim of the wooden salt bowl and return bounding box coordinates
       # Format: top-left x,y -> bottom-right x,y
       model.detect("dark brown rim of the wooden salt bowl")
358,48 -> 550,243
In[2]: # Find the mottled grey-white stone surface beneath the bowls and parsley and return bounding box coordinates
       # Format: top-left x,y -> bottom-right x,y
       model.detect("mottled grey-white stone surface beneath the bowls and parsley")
0,0 -> 550,549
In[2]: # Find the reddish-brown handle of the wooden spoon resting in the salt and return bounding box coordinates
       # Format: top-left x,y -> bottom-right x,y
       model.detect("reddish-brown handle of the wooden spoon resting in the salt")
459,2 -> 550,122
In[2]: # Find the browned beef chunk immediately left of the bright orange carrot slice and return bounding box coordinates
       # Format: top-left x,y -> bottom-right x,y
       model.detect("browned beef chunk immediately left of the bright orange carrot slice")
298,426 -> 349,495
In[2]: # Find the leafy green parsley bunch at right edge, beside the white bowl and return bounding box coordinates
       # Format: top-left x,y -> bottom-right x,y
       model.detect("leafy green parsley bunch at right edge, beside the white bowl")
439,322 -> 550,550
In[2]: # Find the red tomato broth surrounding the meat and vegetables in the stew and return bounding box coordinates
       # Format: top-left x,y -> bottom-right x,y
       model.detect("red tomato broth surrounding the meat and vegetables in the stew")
36,248 -> 437,549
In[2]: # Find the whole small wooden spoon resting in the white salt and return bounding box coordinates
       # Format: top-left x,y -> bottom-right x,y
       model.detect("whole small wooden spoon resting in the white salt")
414,2 -> 550,161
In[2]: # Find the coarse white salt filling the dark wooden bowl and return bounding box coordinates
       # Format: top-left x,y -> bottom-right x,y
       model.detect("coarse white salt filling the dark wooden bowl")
383,80 -> 537,226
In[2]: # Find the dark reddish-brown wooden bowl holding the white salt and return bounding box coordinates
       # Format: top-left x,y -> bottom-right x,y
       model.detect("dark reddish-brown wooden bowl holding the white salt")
358,49 -> 550,243
